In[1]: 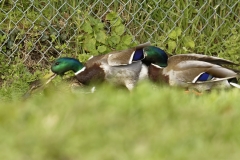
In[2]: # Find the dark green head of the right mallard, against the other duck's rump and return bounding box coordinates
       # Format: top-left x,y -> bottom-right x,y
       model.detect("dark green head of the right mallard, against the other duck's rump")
143,46 -> 168,67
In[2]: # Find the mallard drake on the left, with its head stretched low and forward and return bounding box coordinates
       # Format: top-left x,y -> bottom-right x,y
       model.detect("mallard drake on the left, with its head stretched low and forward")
51,42 -> 154,90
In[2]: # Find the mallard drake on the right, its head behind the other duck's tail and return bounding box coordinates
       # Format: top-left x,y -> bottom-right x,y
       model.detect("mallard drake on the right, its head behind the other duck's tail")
143,46 -> 240,92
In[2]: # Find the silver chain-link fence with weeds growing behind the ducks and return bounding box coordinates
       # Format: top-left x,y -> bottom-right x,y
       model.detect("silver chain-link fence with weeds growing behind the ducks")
0,0 -> 240,65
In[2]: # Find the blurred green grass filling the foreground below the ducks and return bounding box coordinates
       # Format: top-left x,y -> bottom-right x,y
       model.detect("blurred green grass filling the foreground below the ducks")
0,83 -> 240,160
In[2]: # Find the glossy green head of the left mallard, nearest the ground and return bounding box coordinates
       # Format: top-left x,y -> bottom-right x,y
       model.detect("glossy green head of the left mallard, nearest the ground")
51,57 -> 84,75
